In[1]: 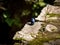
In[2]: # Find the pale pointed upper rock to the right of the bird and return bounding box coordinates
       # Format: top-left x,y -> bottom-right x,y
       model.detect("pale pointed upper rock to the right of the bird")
35,4 -> 60,21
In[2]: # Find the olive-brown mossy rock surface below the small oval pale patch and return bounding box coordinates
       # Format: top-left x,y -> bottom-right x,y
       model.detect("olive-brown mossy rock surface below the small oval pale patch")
29,32 -> 60,45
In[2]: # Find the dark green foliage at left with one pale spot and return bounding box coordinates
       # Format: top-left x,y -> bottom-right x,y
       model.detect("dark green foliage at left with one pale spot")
3,12 -> 22,27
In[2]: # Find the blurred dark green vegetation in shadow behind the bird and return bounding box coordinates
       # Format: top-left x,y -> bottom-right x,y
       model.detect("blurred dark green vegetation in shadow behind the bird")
3,0 -> 46,28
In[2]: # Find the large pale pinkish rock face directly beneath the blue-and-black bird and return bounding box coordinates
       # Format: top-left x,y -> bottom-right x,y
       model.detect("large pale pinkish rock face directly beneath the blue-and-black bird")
13,22 -> 43,41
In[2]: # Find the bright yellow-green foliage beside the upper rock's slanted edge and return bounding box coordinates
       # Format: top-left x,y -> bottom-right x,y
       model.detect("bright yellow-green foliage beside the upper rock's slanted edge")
32,0 -> 46,16
